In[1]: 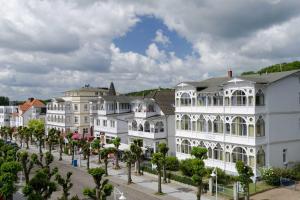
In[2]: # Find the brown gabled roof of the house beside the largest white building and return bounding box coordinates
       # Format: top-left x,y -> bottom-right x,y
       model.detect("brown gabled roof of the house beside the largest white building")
145,90 -> 175,115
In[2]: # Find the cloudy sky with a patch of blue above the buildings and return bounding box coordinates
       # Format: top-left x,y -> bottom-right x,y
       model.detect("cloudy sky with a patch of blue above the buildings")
0,0 -> 300,100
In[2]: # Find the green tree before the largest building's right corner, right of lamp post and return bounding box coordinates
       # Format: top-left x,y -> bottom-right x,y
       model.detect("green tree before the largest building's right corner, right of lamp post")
235,160 -> 254,200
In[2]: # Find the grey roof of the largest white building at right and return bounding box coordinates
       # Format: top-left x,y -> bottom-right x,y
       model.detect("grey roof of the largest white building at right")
180,70 -> 300,93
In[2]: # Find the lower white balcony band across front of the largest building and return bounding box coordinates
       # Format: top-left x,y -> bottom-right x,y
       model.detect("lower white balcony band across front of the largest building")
175,130 -> 267,146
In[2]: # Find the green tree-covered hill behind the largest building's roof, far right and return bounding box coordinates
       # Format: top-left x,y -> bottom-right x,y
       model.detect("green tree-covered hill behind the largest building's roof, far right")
241,61 -> 300,75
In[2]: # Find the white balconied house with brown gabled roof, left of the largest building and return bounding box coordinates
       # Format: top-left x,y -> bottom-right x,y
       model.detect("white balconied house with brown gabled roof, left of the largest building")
128,91 -> 175,157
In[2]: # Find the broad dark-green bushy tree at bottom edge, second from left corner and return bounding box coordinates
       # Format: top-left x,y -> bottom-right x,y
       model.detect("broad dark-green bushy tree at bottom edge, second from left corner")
23,169 -> 57,200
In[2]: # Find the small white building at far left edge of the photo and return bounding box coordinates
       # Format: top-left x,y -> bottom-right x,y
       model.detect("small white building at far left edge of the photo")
0,106 -> 18,127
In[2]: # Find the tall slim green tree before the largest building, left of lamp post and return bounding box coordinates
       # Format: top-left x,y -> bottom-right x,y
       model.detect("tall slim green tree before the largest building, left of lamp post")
191,147 -> 207,200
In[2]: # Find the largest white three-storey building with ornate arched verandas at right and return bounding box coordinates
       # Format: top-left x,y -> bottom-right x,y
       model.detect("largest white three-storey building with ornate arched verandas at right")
175,71 -> 300,175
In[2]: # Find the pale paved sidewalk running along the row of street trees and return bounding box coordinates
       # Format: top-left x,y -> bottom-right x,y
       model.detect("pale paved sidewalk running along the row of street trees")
23,145 -> 215,200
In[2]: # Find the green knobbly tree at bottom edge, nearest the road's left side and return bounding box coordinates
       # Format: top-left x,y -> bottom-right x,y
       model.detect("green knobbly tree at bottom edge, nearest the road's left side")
83,167 -> 113,200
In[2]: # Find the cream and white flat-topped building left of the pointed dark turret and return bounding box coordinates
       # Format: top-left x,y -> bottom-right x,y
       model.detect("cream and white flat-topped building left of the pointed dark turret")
46,85 -> 108,134
